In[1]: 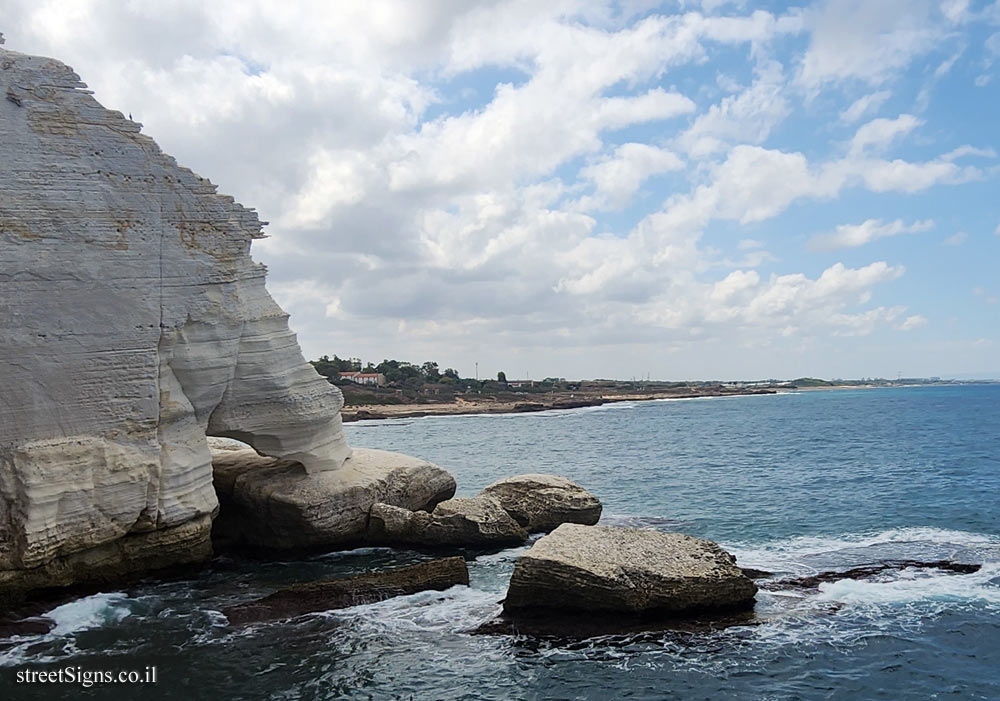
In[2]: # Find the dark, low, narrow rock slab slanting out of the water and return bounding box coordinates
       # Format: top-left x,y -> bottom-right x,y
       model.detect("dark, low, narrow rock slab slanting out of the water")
222,557 -> 469,625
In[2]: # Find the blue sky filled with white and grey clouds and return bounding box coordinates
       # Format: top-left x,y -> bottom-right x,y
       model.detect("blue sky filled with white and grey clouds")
0,0 -> 1000,380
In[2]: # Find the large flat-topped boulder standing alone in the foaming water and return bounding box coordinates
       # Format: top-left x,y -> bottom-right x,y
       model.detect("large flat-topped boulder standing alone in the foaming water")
504,523 -> 757,615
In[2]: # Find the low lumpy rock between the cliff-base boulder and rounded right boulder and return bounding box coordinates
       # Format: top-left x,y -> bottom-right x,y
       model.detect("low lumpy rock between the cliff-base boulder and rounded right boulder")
368,497 -> 528,548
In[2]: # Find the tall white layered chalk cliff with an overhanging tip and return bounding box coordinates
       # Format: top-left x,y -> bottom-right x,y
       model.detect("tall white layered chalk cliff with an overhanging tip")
0,38 -> 350,589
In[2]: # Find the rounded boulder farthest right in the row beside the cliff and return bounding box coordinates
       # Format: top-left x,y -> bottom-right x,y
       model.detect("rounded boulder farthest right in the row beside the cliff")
479,475 -> 601,533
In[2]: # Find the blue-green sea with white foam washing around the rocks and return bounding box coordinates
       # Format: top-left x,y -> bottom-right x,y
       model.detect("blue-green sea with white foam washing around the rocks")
0,385 -> 1000,700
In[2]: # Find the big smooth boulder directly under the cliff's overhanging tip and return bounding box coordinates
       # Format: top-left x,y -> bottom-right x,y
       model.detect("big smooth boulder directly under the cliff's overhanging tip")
214,448 -> 455,550
